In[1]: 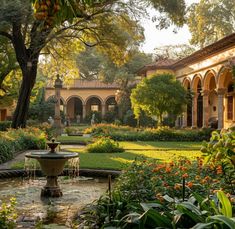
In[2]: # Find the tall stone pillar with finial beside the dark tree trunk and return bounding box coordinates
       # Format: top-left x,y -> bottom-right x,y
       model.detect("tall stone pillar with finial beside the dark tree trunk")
54,75 -> 63,129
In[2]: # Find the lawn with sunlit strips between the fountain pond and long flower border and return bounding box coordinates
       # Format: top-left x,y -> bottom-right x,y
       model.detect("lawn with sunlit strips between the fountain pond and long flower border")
65,142 -> 201,170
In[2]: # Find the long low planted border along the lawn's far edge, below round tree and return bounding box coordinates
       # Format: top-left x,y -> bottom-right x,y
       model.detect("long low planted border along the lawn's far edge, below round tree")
84,124 -> 211,141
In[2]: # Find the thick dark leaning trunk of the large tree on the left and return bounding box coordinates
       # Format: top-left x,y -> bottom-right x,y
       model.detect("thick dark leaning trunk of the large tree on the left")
12,63 -> 37,129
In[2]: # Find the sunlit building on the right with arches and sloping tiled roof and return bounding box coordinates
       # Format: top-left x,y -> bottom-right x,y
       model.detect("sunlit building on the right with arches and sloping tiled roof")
140,33 -> 235,129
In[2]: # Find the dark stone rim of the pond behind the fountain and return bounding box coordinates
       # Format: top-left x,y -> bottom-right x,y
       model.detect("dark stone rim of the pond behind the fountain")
0,169 -> 121,179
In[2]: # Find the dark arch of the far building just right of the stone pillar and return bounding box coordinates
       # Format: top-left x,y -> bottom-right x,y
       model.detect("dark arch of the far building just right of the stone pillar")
66,95 -> 84,123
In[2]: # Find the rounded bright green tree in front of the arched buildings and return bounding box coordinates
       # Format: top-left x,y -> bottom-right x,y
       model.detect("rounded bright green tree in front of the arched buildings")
131,74 -> 187,125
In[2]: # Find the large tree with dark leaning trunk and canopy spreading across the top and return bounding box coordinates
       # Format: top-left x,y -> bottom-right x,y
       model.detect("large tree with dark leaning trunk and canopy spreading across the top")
0,0 -> 185,128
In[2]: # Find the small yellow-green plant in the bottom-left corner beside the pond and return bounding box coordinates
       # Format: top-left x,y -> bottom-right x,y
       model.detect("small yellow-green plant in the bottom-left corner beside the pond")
0,198 -> 17,229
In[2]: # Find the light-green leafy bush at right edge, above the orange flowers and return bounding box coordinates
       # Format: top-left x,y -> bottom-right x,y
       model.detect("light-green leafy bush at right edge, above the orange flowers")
201,130 -> 235,193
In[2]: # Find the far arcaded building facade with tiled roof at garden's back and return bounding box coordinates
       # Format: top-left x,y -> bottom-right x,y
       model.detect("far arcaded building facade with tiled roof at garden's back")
45,79 -> 118,122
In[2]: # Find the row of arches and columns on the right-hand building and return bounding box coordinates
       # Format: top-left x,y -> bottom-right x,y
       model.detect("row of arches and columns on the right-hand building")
181,66 -> 235,129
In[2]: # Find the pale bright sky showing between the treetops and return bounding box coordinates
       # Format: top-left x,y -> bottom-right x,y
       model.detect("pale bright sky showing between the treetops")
141,0 -> 199,53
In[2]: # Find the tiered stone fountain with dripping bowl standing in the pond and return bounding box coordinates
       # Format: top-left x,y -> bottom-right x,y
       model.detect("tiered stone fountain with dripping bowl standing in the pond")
25,139 -> 79,197
